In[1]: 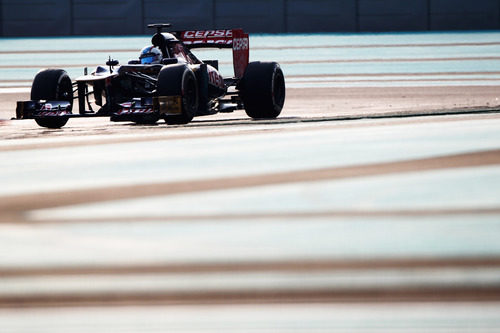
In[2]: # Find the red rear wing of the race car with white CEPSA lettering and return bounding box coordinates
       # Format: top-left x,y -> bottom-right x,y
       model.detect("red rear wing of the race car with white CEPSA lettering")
176,29 -> 250,78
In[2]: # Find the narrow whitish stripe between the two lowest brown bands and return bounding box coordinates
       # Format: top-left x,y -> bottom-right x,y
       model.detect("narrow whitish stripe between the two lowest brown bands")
0,267 -> 500,297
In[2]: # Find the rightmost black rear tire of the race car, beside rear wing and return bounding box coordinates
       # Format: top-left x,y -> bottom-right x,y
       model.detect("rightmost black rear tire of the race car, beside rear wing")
239,61 -> 286,119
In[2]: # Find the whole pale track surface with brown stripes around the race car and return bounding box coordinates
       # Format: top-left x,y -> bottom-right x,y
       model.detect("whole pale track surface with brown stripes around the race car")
0,32 -> 500,332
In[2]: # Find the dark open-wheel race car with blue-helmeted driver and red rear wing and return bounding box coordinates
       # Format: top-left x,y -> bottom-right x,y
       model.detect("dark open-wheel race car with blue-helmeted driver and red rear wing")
16,24 -> 285,128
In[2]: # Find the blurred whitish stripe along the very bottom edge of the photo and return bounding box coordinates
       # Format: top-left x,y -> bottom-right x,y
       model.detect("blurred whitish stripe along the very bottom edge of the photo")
0,302 -> 500,333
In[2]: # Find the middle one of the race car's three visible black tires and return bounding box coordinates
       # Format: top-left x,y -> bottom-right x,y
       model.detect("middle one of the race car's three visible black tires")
157,64 -> 199,125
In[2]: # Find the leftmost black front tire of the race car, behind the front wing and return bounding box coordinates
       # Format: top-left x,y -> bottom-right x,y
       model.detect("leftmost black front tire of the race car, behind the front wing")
31,69 -> 73,128
